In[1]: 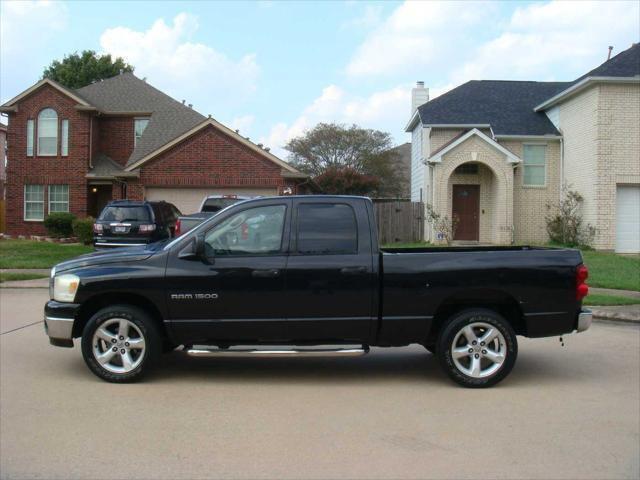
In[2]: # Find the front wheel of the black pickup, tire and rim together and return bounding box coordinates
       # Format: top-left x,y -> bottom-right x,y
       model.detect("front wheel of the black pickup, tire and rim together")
82,305 -> 162,383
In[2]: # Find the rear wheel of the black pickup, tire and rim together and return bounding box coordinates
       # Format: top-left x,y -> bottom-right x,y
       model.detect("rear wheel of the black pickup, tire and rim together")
436,308 -> 518,388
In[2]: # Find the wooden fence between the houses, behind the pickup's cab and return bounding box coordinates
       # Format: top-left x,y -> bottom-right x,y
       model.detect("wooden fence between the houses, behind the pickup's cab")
373,200 -> 424,244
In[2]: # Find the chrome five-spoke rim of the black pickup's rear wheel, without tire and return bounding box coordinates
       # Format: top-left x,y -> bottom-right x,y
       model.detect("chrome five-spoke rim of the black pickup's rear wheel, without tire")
451,322 -> 507,378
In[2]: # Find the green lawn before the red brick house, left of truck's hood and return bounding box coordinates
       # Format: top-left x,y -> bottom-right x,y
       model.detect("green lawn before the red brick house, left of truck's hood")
0,240 -> 93,268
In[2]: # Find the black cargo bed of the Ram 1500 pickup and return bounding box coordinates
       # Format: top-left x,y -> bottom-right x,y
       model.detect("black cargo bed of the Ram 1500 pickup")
378,246 -> 582,344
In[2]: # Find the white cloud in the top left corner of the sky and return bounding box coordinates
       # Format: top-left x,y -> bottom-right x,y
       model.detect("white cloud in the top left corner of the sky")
0,1 -> 67,56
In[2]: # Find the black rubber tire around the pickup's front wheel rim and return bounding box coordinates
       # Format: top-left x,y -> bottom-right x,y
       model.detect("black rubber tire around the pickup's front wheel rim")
81,305 -> 162,383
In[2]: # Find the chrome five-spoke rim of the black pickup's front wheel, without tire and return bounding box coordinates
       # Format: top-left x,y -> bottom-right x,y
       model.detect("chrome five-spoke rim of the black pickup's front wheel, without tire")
91,318 -> 145,373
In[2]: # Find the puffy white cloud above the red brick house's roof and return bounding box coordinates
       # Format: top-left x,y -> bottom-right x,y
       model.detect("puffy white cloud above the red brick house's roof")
100,13 -> 260,111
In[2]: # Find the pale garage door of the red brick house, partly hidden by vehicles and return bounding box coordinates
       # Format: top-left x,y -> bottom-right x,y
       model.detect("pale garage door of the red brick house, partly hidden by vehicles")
145,187 -> 277,215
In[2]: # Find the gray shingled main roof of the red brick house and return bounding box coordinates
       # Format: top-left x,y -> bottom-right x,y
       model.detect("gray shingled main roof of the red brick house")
75,73 -> 206,165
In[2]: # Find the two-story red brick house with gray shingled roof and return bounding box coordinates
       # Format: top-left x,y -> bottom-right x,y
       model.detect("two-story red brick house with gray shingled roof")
0,73 -> 309,235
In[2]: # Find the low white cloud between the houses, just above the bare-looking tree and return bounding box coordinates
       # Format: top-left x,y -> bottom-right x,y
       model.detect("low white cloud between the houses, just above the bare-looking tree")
260,85 -> 411,158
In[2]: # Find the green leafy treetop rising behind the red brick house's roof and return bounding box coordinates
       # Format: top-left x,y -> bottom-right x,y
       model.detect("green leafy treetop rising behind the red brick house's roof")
42,50 -> 133,89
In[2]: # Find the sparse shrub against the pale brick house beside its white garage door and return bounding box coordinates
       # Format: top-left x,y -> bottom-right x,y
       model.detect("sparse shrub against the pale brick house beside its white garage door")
545,185 -> 596,247
